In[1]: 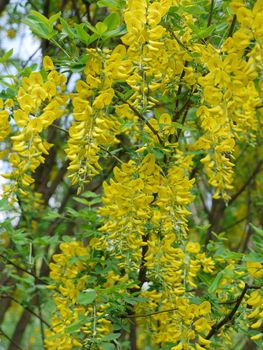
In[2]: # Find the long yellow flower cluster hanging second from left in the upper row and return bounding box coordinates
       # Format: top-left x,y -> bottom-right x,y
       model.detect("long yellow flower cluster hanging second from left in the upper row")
66,45 -> 134,189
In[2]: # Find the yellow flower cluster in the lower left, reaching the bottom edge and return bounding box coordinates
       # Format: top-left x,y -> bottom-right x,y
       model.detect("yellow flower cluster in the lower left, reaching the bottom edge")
45,239 -> 111,350
